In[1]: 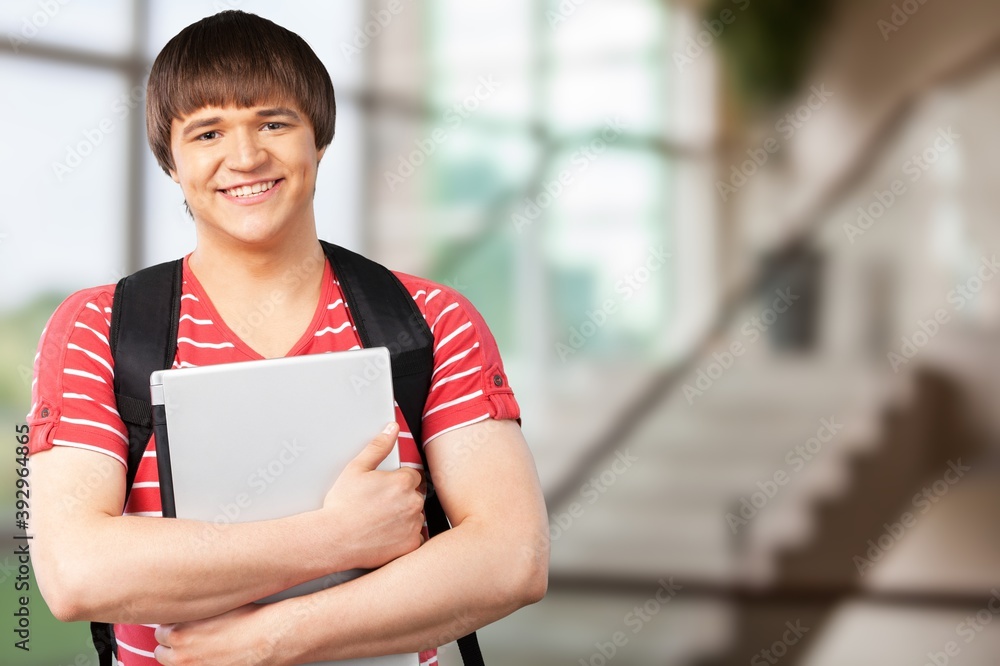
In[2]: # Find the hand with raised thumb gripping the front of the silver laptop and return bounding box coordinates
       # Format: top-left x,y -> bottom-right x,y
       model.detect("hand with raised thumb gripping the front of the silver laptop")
323,423 -> 424,569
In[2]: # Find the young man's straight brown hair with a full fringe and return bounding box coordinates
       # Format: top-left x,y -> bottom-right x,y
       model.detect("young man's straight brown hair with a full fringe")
146,10 -> 337,173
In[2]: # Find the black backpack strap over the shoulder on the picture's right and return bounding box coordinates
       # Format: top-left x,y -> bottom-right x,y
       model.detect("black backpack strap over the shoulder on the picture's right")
320,241 -> 483,666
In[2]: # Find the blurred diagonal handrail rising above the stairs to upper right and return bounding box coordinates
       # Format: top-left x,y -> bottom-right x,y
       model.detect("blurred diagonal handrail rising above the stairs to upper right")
545,33 -> 1000,512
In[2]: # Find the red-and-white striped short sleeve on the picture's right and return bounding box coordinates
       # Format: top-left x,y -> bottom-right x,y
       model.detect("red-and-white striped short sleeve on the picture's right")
397,274 -> 521,444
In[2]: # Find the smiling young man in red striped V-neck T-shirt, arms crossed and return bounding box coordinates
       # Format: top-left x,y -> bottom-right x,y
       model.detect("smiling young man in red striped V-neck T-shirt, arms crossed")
29,12 -> 548,666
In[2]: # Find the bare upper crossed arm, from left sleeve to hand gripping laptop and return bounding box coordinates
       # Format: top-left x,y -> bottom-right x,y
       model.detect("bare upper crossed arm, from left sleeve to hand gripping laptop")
30,425 -> 422,624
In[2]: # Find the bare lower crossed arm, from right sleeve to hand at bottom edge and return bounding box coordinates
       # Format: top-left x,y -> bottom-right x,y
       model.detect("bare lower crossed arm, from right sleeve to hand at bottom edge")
156,419 -> 549,664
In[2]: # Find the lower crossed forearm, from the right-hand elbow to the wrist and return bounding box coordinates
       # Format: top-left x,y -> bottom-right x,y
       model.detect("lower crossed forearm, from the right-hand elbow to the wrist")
270,519 -> 548,664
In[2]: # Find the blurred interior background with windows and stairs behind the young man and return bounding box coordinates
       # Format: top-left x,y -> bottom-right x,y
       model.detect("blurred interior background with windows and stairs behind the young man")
0,0 -> 1000,666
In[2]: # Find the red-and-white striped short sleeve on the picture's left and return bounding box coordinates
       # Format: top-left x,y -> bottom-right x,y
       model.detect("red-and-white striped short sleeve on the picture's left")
27,285 -> 128,465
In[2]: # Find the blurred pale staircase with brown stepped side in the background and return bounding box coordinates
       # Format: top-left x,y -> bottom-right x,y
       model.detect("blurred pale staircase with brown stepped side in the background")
464,343 -> 980,666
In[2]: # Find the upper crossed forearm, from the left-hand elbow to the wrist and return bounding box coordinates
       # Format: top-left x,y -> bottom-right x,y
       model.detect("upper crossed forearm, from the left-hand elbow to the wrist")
35,512 -> 349,624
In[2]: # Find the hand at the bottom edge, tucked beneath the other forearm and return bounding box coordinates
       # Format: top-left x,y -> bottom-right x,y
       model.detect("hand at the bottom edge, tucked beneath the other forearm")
153,604 -> 290,666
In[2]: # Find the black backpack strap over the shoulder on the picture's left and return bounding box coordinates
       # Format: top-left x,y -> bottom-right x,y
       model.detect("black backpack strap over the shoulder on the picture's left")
90,259 -> 183,666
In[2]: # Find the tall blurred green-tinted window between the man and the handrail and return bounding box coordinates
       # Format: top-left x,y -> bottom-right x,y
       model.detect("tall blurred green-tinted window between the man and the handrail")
423,0 -> 673,361
